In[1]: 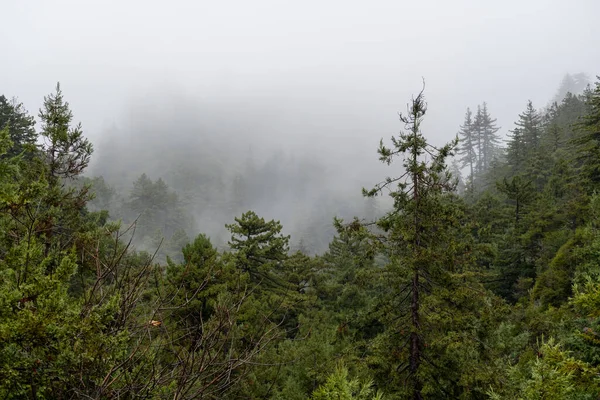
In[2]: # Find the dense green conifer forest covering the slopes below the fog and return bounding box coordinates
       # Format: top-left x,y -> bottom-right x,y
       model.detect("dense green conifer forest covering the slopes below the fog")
0,74 -> 600,400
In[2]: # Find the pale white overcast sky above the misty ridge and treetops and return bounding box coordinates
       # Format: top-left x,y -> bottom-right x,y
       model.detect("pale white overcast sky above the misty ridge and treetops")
0,0 -> 600,157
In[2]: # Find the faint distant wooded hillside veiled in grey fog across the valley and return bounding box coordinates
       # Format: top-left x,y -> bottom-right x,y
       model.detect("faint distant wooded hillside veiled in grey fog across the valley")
83,98 -> 379,254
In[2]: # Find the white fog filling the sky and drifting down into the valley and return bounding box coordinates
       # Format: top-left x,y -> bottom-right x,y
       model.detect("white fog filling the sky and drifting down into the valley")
0,0 -> 600,253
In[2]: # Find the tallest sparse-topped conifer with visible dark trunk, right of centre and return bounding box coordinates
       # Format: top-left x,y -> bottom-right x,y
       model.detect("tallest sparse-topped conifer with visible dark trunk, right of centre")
363,86 -> 458,400
